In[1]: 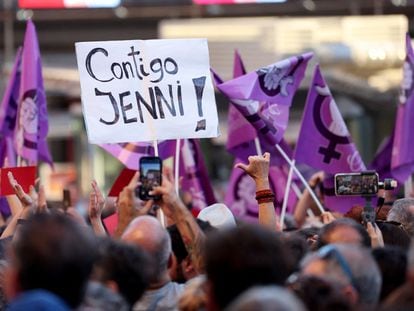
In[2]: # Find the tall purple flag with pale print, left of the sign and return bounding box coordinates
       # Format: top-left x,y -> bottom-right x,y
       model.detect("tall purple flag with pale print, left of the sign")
15,20 -> 53,166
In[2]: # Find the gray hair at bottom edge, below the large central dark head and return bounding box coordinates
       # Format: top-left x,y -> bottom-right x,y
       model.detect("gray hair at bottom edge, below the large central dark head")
225,286 -> 306,311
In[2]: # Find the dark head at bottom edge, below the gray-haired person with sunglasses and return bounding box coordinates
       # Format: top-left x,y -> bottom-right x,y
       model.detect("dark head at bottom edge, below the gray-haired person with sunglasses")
288,275 -> 353,311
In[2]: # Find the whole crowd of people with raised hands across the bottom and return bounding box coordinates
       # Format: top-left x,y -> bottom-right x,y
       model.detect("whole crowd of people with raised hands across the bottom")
0,153 -> 414,311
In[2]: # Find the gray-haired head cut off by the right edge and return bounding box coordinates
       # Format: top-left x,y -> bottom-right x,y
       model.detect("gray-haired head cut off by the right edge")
387,198 -> 414,236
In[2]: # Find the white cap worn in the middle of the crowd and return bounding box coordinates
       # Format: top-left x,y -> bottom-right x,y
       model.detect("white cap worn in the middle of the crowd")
197,203 -> 236,229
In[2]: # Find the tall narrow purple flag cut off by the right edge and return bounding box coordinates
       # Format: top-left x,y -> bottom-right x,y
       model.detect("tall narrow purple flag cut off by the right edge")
391,34 -> 414,183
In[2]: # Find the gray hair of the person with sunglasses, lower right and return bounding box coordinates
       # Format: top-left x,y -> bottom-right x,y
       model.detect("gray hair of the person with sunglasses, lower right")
302,244 -> 382,305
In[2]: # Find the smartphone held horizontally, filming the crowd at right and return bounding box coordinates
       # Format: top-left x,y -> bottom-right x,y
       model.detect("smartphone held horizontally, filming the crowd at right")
335,171 -> 379,196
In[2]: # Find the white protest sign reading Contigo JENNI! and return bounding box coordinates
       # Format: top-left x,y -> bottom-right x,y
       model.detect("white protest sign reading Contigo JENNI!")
76,39 -> 218,144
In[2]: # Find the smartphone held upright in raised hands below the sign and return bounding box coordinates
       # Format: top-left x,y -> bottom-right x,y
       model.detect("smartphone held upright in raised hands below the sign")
136,157 -> 162,201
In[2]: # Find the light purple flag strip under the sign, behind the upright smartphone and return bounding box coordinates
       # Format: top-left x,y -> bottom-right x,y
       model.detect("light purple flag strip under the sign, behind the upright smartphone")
99,140 -> 177,170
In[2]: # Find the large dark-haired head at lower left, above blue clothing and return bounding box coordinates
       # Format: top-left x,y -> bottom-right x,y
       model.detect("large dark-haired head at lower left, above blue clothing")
6,214 -> 96,308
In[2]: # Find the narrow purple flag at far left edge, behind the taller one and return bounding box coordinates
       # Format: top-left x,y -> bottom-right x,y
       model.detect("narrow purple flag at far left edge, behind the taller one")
0,48 -> 22,138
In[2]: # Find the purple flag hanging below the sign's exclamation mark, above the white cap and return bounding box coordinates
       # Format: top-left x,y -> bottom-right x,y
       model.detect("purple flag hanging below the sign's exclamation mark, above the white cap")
180,139 -> 217,214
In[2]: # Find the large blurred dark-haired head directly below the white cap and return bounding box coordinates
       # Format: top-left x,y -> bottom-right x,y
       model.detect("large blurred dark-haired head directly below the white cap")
205,225 -> 289,309
